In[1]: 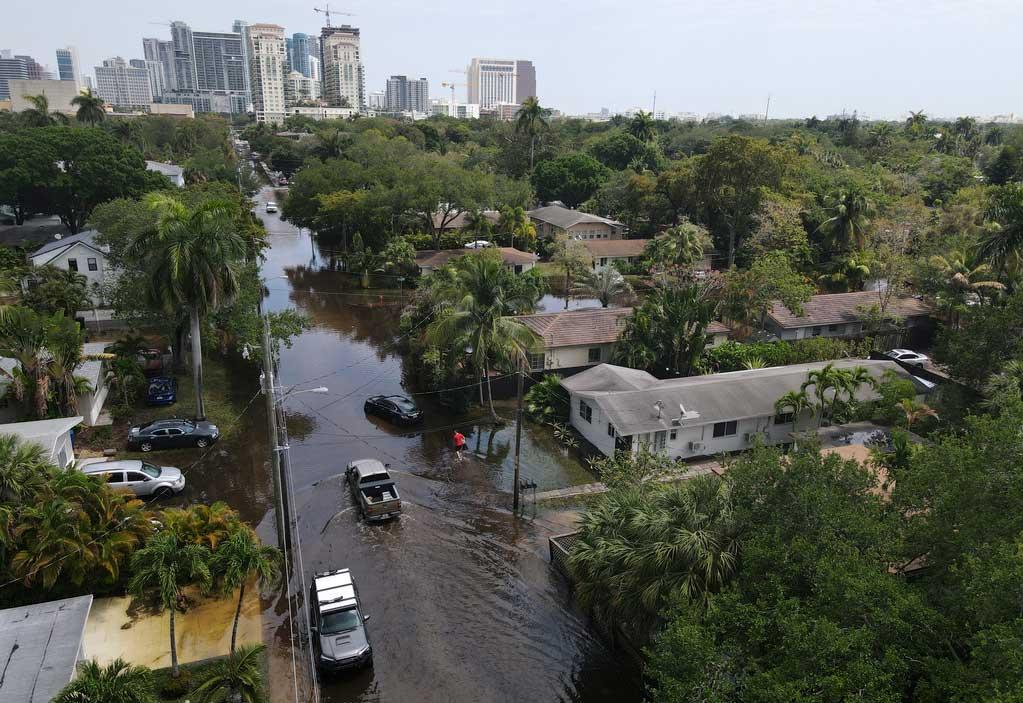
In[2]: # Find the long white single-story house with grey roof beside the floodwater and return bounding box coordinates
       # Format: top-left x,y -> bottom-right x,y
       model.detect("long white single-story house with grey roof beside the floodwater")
562,359 -> 913,459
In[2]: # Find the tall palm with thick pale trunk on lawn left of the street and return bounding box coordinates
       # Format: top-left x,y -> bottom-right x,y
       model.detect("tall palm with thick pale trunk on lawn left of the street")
132,192 -> 247,420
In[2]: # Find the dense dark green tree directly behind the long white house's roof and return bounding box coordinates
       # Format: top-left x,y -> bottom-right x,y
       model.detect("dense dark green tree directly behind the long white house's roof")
615,282 -> 717,378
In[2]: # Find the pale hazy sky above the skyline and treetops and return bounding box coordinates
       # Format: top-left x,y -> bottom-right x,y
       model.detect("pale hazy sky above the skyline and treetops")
0,0 -> 1023,118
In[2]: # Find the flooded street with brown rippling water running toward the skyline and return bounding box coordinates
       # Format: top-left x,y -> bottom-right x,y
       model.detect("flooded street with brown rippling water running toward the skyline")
241,191 -> 640,703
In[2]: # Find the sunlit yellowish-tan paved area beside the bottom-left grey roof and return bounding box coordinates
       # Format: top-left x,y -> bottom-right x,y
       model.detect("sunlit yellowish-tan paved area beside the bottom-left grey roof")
82,584 -> 263,669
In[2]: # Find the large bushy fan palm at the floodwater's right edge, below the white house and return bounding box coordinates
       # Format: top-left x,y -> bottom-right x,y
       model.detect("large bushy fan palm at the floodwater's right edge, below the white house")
568,476 -> 739,636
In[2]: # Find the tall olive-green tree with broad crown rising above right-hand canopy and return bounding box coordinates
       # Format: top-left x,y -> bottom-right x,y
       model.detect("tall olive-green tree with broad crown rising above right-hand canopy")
697,135 -> 788,268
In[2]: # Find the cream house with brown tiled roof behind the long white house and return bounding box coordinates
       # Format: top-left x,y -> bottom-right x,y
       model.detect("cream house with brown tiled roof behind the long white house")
512,308 -> 728,375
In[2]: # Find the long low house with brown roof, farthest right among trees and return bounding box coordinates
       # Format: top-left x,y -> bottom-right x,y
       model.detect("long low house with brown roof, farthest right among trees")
764,291 -> 931,340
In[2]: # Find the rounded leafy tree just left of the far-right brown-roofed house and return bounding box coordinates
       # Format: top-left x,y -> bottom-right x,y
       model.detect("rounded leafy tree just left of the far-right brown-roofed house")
722,252 -> 814,329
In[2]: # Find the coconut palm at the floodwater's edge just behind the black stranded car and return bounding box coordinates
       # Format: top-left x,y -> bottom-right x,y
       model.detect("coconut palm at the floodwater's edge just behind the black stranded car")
427,252 -> 536,422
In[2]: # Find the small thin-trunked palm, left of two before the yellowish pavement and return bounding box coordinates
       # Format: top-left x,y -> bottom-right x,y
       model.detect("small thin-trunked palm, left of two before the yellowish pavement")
128,532 -> 212,678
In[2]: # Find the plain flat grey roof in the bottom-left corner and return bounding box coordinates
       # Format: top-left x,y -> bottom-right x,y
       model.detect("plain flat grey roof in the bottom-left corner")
0,596 -> 92,703
